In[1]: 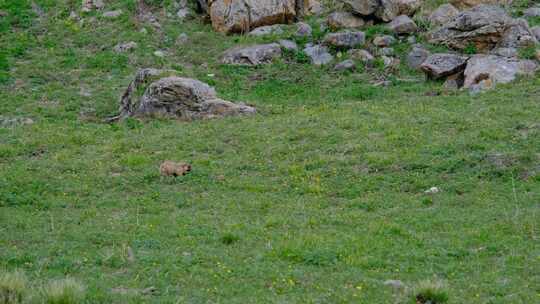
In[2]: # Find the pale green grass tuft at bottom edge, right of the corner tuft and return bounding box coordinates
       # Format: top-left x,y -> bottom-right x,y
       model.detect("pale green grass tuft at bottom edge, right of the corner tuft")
43,278 -> 85,304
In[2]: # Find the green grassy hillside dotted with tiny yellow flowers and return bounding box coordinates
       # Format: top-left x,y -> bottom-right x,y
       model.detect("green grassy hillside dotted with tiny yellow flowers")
0,0 -> 540,303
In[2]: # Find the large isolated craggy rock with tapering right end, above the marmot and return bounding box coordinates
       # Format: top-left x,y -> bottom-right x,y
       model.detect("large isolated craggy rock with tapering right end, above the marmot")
118,69 -> 256,120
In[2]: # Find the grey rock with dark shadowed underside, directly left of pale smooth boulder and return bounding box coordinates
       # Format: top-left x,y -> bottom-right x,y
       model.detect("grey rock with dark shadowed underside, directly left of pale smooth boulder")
420,54 -> 467,79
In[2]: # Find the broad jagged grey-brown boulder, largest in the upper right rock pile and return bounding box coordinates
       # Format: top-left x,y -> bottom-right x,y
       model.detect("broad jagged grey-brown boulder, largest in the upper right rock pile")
428,5 -> 513,52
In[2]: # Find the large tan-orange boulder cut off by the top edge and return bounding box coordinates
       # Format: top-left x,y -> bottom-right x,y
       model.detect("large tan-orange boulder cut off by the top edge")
209,0 -> 296,33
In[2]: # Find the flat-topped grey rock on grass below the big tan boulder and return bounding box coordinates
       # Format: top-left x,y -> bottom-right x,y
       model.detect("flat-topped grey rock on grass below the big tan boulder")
221,43 -> 281,65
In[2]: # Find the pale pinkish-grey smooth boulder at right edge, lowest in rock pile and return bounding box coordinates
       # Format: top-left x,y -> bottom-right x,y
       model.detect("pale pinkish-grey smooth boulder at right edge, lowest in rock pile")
463,55 -> 538,90
